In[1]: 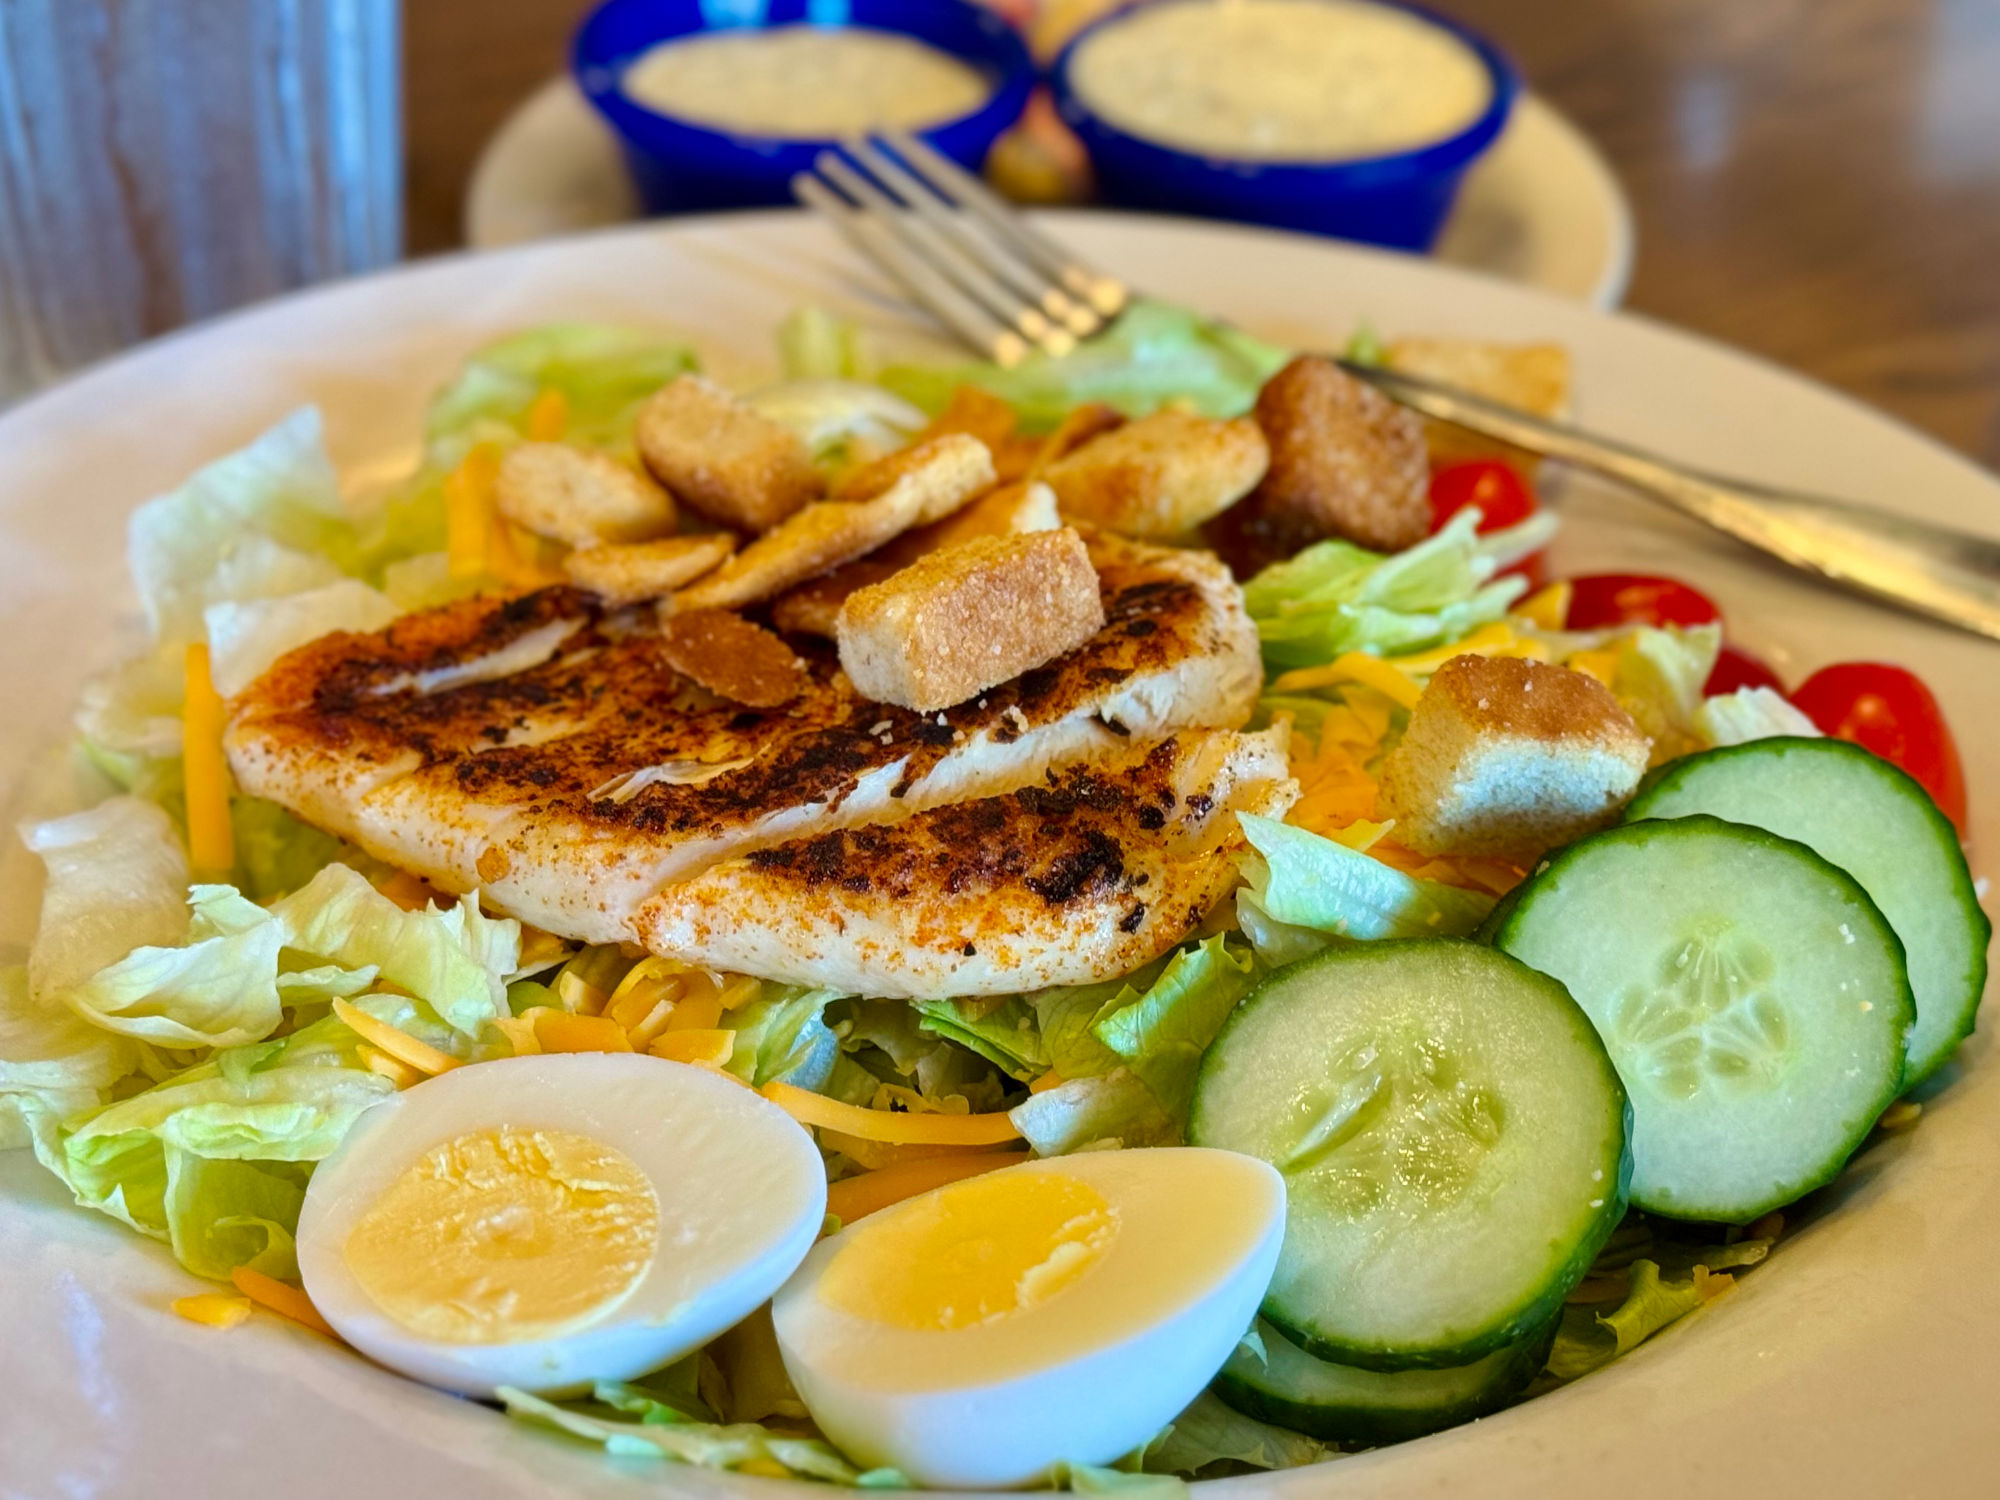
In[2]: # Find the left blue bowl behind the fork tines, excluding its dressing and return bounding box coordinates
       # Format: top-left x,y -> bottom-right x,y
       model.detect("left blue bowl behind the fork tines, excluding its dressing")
570,0 -> 1036,214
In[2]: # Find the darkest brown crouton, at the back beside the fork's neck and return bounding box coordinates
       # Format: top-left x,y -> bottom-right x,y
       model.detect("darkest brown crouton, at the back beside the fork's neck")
1208,354 -> 1430,572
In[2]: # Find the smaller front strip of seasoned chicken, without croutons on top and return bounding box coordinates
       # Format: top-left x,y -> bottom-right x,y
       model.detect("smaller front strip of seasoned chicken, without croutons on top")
638,730 -> 1298,996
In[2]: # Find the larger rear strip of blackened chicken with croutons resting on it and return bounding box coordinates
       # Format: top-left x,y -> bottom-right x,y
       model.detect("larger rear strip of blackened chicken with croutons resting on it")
228,538 -> 1262,942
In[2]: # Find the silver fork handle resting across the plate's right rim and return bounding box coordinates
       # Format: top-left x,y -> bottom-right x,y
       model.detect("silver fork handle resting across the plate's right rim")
1340,360 -> 2000,640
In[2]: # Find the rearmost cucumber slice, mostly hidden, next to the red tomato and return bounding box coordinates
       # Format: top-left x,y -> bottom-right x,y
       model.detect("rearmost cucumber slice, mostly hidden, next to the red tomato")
1626,738 -> 1992,1090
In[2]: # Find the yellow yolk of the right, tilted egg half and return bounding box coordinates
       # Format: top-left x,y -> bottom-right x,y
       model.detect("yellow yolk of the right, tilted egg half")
820,1172 -> 1118,1332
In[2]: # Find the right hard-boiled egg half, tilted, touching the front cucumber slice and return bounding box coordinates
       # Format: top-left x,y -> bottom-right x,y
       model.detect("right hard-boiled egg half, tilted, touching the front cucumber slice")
772,1148 -> 1284,1488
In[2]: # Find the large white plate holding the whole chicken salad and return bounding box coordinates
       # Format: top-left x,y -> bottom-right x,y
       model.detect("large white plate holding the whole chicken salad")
0,214 -> 2000,1500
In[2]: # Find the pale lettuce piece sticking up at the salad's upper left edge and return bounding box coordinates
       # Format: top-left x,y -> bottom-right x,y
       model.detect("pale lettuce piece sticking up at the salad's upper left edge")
126,406 -> 354,644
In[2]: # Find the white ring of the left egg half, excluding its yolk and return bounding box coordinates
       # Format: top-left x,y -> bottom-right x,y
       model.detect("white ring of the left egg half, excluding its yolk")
298,1052 -> 826,1396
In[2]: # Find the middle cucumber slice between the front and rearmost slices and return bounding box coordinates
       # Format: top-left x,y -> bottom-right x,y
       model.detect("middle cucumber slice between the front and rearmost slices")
1494,816 -> 1916,1224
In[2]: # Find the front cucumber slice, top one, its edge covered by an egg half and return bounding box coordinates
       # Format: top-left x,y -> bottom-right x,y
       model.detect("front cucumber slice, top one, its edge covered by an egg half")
1188,938 -> 1630,1370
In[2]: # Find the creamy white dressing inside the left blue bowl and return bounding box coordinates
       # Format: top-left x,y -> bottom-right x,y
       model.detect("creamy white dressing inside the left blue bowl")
622,26 -> 992,140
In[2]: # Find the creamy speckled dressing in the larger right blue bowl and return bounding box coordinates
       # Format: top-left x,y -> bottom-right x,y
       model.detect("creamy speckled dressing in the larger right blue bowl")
1070,0 -> 1492,162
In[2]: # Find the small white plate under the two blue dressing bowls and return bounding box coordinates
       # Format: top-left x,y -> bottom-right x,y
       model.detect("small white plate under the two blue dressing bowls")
466,78 -> 1632,308
